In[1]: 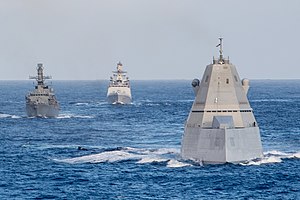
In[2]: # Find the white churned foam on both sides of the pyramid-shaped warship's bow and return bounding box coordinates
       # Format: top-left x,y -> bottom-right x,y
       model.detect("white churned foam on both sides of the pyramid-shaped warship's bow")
56,145 -> 300,168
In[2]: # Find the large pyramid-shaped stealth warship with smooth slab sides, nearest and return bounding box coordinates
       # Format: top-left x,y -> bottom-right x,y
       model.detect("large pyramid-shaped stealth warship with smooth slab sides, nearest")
181,38 -> 263,164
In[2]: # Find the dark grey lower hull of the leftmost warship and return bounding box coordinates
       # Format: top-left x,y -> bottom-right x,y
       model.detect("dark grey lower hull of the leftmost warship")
26,104 -> 59,117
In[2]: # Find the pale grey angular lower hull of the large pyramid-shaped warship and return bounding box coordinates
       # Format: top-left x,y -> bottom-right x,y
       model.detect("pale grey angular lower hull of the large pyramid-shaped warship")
181,127 -> 263,164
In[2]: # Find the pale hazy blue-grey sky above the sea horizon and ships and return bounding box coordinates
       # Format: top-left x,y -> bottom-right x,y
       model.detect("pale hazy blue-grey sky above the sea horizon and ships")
0,0 -> 300,80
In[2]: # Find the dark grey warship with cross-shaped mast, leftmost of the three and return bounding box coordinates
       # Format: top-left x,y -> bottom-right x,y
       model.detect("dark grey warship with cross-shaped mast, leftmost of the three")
25,64 -> 60,117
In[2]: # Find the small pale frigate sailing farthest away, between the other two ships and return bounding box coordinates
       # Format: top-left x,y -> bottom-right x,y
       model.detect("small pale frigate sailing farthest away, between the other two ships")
107,62 -> 131,104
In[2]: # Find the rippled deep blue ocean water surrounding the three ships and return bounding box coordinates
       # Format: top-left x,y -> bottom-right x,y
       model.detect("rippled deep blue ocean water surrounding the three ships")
0,80 -> 300,199
